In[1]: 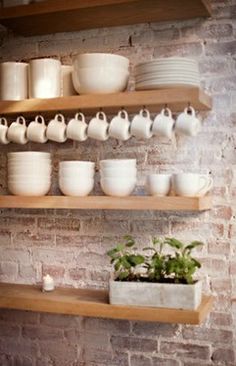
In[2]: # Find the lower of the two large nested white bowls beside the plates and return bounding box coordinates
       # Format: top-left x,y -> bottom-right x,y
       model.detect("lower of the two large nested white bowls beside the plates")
72,66 -> 129,94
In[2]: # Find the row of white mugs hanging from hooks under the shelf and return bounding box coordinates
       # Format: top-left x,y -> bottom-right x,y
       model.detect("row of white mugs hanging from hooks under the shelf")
0,107 -> 201,145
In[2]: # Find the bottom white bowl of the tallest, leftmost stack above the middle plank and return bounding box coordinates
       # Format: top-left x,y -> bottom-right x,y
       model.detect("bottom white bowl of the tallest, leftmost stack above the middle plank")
8,181 -> 51,196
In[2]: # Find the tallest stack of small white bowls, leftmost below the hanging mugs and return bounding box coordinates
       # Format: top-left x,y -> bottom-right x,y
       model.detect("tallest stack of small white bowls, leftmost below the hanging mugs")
8,151 -> 52,196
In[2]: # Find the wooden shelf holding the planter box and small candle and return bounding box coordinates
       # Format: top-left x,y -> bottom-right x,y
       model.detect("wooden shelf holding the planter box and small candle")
0,284 -> 213,324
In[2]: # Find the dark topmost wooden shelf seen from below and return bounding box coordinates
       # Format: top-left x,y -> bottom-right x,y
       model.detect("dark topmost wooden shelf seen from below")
0,0 -> 211,36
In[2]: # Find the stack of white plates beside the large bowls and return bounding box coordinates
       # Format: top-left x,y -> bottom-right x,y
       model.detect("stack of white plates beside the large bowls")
134,57 -> 200,90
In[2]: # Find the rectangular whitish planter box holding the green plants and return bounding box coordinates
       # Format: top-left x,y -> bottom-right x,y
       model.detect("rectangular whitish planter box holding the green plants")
109,280 -> 202,310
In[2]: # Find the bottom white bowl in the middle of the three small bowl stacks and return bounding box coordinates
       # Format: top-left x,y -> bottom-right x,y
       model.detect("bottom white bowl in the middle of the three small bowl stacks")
59,178 -> 94,197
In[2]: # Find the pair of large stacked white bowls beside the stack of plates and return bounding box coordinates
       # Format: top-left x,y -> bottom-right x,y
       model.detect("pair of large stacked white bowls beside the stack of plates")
72,53 -> 129,94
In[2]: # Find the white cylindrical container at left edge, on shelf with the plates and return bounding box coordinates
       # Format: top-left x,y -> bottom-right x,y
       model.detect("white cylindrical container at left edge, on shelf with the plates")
0,62 -> 28,100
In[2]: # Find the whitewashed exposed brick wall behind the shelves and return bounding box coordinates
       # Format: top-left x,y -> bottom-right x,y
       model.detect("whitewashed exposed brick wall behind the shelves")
0,0 -> 236,366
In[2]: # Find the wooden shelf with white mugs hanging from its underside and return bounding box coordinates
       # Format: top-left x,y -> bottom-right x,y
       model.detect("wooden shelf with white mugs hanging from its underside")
0,88 -> 212,116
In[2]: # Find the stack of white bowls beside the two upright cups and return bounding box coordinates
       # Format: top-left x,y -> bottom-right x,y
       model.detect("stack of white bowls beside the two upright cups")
100,159 -> 137,197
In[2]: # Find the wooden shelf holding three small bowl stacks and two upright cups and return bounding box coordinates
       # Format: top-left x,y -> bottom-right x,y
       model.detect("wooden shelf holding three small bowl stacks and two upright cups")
0,196 -> 212,211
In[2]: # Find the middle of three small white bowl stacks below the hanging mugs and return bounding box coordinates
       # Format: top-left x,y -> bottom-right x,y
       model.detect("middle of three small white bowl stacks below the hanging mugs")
59,161 -> 95,197
